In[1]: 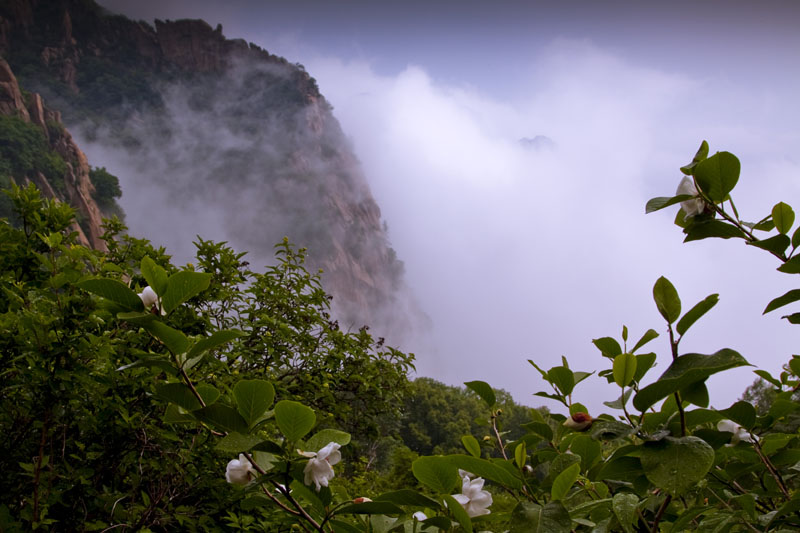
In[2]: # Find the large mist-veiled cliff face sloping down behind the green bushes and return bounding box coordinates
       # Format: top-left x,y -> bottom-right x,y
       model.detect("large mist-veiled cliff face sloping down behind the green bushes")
0,0 -> 422,330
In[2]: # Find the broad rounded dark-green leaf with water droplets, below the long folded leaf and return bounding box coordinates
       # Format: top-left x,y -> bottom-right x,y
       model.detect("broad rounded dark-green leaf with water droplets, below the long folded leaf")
639,436 -> 714,495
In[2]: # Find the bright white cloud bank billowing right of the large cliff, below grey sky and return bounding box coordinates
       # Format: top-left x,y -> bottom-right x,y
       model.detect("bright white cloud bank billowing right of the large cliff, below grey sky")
306,41 -> 800,411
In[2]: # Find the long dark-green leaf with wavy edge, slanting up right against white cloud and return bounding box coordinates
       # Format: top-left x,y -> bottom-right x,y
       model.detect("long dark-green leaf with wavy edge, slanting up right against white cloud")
633,348 -> 750,411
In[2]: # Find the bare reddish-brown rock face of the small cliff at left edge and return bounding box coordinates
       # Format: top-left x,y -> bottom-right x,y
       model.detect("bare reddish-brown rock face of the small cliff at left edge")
0,58 -> 105,249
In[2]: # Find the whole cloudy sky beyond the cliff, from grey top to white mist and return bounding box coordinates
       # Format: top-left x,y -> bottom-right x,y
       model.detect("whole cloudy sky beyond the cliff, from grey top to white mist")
97,0 -> 800,414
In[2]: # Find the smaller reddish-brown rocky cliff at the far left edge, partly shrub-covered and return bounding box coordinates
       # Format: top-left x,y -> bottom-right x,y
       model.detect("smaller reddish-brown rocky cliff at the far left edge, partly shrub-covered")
0,58 -> 104,248
